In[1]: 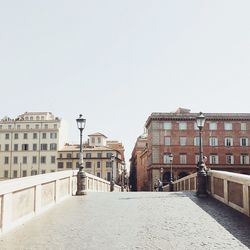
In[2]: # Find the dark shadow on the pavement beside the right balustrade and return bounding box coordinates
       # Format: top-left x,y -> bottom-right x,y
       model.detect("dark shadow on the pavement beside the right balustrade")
187,193 -> 250,248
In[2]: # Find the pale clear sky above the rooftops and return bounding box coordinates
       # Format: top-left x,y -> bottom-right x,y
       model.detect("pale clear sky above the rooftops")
0,0 -> 250,165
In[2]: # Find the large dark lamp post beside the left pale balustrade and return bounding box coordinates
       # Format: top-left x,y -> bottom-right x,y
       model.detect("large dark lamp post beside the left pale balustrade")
76,115 -> 86,195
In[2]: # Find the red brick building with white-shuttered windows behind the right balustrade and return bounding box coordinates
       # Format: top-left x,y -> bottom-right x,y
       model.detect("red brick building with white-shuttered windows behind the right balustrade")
135,108 -> 250,190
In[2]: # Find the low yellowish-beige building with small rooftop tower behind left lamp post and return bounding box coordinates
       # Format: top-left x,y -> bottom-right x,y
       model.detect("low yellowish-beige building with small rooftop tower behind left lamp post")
57,133 -> 125,183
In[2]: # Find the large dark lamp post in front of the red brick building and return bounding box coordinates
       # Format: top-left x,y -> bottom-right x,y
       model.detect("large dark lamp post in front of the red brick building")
196,112 -> 207,197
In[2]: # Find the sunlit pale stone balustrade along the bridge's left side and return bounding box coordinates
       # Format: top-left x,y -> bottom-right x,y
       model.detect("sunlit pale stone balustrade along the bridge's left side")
0,170 -> 121,234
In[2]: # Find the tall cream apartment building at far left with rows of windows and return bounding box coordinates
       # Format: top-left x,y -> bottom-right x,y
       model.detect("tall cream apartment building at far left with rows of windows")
0,112 -> 67,179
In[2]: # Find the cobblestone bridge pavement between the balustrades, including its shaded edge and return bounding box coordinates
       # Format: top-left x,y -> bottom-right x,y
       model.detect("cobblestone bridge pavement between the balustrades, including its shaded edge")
0,192 -> 250,250
